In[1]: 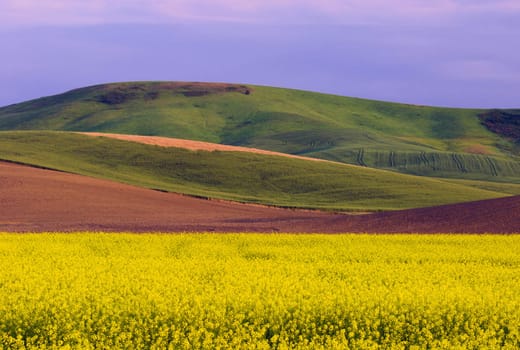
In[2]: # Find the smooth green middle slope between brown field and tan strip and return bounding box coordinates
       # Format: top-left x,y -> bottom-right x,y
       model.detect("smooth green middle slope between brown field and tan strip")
0,131 -> 508,210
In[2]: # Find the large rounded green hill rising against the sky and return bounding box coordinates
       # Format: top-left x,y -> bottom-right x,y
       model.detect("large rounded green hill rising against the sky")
0,83 -> 520,183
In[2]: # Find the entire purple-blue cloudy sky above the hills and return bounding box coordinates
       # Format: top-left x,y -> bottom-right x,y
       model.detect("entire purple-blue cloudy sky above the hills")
0,0 -> 520,108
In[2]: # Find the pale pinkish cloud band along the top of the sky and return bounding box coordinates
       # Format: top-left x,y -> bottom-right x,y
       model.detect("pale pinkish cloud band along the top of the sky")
0,0 -> 520,27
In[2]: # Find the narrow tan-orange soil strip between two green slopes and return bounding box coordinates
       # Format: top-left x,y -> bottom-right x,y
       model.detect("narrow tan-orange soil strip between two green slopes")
78,132 -> 329,162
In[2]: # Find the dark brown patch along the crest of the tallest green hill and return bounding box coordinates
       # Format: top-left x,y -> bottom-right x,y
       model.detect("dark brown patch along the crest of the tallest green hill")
95,82 -> 252,105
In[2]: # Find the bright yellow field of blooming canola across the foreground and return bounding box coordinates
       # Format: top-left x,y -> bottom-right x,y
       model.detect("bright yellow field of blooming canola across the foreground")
0,233 -> 520,349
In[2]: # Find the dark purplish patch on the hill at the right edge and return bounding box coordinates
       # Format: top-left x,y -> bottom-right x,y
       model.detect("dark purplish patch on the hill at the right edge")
479,109 -> 520,142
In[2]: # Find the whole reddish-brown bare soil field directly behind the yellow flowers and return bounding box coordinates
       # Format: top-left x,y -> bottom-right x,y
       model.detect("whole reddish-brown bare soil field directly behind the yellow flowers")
0,162 -> 520,233
